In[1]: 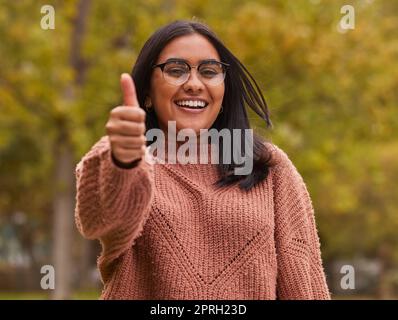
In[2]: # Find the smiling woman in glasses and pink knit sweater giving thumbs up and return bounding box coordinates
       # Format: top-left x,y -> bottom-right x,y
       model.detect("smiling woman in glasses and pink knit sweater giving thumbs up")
75,21 -> 330,299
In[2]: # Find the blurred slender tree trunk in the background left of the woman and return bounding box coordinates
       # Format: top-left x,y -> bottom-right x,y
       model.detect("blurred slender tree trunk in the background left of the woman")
52,0 -> 90,299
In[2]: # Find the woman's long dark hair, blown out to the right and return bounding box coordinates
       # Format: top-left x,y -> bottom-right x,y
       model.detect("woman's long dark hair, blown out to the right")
132,20 -> 271,190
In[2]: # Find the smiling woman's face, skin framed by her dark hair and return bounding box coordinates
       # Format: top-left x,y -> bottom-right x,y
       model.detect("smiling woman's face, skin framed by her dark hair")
150,33 -> 225,134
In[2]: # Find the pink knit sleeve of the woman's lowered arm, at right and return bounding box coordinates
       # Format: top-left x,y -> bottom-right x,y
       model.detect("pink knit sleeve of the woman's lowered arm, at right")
272,146 -> 330,300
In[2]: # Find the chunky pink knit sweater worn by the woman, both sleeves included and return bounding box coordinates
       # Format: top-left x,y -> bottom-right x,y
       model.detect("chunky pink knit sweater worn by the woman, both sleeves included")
75,137 -> 330,300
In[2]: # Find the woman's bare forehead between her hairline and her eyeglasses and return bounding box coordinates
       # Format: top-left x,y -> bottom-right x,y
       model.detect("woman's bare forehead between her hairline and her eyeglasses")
158,33 -> 220,64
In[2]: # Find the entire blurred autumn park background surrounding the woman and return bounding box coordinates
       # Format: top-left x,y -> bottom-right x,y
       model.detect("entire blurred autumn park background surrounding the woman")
0,0 -> 398,299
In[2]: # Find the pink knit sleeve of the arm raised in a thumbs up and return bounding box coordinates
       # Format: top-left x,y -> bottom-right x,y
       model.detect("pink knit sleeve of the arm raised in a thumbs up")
75,136 -> 154,282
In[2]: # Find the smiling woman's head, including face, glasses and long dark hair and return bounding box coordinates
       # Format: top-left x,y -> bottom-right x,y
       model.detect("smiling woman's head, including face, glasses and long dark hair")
132,21 -> 271,190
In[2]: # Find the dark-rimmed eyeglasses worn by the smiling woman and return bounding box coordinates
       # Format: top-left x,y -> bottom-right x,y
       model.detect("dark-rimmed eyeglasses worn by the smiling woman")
152,59 -> 229,86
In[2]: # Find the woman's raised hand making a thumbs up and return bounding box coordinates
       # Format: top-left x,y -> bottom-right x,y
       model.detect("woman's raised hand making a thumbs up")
105,73 -> 146,164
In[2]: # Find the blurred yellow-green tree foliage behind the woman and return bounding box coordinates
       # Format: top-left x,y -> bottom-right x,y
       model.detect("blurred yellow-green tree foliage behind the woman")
0,0 -> 398,276
